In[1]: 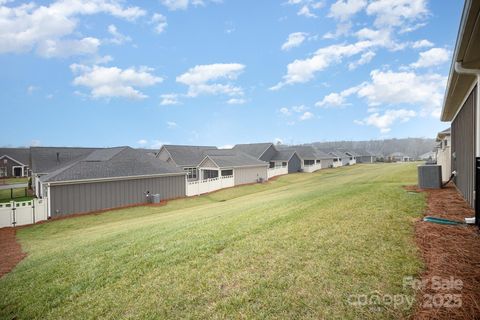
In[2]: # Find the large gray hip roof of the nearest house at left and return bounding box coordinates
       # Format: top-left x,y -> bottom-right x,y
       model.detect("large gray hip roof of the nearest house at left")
40,147 -> 184,182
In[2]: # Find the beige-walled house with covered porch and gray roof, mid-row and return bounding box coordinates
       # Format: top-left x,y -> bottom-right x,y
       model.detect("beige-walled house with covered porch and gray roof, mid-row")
198,149 -> 268,186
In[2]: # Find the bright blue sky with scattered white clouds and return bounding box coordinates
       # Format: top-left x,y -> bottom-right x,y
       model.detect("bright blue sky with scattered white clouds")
0,0 -> 463,148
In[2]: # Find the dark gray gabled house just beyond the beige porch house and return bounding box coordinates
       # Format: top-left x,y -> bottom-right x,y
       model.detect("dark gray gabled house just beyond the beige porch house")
233,142 -> 301,173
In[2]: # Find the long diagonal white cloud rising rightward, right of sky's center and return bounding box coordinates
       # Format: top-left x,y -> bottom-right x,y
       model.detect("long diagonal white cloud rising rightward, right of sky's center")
270,41 -> 374,90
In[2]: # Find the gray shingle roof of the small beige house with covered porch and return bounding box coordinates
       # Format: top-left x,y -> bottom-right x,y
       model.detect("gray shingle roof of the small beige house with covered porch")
204,149 -> 268,168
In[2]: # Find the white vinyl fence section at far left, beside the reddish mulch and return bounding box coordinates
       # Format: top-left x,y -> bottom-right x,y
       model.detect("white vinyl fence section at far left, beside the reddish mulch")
0,199 -> 48,228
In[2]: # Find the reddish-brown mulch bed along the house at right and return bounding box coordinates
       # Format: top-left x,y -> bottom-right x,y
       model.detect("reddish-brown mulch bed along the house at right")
407,184 -> 480,319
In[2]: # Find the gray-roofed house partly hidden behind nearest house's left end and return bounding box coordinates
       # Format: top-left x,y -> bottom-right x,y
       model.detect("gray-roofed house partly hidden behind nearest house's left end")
30,147 -> 98,198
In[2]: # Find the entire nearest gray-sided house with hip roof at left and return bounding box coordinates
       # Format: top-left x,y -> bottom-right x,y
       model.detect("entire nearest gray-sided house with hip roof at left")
39,147 -> 186,217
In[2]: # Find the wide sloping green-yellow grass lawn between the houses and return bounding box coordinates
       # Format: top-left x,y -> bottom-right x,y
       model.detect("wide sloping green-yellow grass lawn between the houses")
0,164 -> 424,319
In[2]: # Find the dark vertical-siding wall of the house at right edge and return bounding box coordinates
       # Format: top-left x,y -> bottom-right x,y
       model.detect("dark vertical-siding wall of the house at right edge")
452,87 -> 477,207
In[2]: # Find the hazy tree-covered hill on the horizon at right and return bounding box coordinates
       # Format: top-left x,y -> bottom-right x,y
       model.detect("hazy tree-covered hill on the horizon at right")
310,138 -> 435,159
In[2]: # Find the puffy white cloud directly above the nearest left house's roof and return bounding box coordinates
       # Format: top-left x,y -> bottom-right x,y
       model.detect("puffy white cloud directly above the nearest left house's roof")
70,64 -> 163,99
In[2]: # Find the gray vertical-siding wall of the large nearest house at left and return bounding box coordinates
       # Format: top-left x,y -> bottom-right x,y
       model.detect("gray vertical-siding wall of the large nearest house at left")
49,175 -> 185,217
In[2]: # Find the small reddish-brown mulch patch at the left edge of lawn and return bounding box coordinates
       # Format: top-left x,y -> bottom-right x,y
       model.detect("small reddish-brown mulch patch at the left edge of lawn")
0,228 -> 27,278
